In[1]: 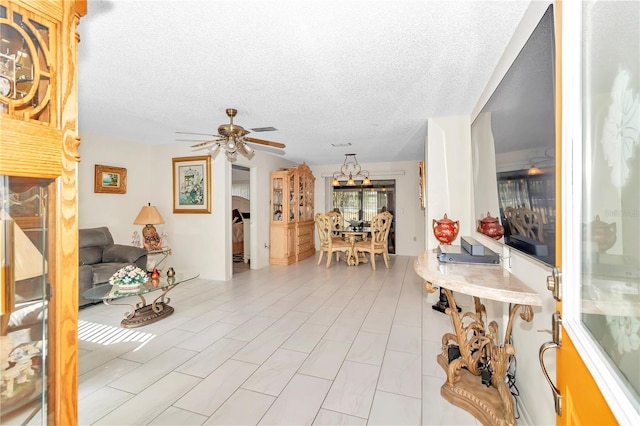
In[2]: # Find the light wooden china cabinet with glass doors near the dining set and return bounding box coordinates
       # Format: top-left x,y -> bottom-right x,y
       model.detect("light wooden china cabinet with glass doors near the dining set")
269,163 -> 316,265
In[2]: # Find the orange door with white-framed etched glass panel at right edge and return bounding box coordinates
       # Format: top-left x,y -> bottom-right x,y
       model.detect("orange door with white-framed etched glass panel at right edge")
556,1 -> 640,425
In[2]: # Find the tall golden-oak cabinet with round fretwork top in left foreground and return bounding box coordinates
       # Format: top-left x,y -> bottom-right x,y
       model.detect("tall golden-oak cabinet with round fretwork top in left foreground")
0,0 -> 87,425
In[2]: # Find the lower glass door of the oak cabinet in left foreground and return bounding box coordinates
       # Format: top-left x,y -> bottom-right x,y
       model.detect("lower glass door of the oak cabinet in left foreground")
0,175 -> 53,424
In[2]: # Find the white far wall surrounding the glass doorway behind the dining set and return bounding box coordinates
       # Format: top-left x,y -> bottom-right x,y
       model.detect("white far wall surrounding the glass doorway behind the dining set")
309,161 -> 425,256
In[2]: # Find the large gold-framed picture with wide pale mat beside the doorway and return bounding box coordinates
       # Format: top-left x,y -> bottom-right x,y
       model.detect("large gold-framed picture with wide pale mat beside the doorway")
173,155 -> 211,213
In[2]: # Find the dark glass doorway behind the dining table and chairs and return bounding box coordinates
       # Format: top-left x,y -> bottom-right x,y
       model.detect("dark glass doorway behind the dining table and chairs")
332,180 -> 396,254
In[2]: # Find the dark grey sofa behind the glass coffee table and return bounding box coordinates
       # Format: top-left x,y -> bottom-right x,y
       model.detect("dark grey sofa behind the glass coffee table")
78,226 -> 147,307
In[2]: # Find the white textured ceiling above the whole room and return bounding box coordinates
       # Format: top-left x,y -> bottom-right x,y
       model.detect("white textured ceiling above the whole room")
78,0 -> 529,164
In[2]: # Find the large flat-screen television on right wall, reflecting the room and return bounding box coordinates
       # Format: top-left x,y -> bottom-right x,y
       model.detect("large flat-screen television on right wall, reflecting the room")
471,5 -> 556,265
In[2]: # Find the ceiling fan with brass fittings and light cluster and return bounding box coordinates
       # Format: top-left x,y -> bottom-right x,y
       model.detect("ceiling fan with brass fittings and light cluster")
176,108 -> 285,162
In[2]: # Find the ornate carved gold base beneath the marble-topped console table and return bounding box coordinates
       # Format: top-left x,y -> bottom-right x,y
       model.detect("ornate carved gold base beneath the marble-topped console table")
426,282 -> 533,426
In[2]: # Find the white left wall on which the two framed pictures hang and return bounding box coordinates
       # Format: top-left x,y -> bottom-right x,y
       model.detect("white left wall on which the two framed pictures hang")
78,132 -> 293,280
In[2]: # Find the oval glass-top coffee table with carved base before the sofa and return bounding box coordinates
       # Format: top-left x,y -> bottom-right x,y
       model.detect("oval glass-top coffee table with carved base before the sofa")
82,272 -> 200,328
